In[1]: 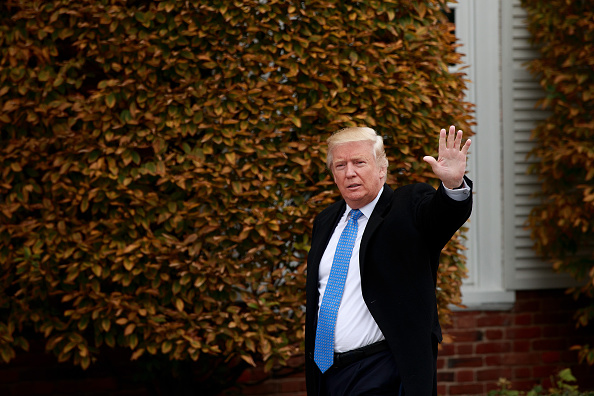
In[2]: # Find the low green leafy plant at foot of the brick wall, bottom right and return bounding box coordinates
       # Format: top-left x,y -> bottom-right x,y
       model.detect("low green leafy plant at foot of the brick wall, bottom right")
489,368 -> 594,396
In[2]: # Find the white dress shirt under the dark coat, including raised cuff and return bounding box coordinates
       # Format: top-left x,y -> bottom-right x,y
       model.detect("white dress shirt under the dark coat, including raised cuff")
318,181 -> 470,352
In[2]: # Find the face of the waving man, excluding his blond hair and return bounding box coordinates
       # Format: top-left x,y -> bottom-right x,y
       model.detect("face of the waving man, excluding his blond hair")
331,141 -> 386,209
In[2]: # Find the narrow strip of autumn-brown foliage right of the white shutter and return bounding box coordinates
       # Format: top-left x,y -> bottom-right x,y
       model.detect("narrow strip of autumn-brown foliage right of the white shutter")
522,0 -> 594,364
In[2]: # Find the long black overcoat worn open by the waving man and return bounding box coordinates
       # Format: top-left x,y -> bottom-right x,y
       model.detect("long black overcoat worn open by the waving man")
305,178 -> 472,396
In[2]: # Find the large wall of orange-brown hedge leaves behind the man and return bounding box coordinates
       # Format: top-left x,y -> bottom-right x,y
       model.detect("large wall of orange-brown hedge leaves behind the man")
0,0 -> 471,390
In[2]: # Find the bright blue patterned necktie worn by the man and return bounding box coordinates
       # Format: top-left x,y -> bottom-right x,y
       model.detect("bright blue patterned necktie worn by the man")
314,209 -> 363,373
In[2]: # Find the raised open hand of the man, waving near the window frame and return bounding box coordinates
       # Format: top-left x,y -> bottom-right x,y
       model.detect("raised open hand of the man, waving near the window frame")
423,125 -> 471,189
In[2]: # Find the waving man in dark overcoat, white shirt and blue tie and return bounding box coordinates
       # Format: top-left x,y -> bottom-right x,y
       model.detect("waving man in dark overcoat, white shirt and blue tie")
305,126 -> 472,396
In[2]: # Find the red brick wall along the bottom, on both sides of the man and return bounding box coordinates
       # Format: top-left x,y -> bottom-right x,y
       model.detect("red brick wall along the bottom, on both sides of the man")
0,290 -> 594,396
